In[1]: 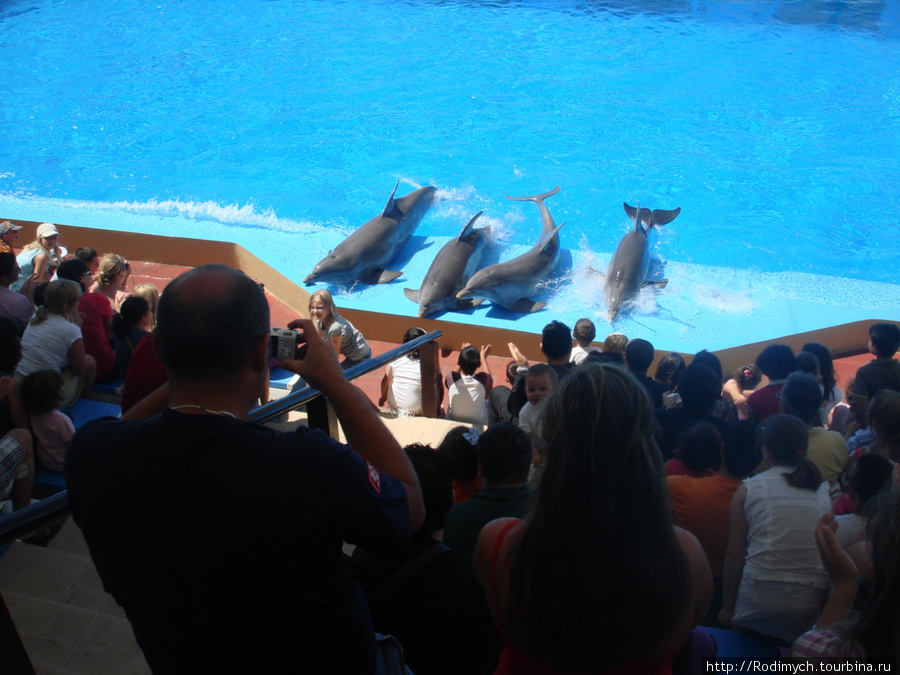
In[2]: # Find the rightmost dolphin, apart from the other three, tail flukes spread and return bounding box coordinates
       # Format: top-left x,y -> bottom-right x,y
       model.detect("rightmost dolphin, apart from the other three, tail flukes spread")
603,202 -> 681,322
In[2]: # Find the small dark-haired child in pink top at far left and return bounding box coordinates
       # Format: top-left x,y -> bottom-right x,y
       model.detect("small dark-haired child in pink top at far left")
22,369 -> 75,473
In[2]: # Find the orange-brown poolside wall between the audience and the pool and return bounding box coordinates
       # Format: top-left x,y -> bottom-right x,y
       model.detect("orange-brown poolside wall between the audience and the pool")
7,217 -> 900,374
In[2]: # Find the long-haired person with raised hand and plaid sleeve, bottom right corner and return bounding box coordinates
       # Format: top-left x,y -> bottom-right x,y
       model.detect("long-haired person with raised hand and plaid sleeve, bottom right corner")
791,489 -> 900,664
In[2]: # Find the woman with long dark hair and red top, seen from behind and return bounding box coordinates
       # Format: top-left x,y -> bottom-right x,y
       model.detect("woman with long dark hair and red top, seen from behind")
474,365 -> 712,674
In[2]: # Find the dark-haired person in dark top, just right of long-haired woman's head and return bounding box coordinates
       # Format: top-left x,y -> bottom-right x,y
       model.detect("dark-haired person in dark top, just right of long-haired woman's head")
656,363 -> 731,461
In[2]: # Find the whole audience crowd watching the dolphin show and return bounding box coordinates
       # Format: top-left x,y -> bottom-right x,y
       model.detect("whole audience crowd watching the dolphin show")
0,222 -> 900,675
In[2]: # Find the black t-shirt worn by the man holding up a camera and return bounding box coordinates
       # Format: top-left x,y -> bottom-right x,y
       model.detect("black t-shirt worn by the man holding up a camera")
65,410 -> 409,673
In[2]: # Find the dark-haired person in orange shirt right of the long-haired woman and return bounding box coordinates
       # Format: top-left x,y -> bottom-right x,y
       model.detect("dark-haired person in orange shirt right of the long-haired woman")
666,420 -> 762,592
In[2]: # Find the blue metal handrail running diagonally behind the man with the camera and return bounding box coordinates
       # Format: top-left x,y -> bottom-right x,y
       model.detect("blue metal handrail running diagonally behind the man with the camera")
0,330 -> 442,546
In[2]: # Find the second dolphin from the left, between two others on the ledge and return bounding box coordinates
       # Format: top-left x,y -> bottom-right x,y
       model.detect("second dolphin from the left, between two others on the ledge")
403,211 -> 491,317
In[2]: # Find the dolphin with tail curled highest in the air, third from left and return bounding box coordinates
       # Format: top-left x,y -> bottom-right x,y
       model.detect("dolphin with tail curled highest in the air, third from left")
456,185 -> 565,314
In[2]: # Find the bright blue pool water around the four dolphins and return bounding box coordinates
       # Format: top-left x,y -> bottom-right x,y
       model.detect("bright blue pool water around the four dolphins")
0,0 -> 900,352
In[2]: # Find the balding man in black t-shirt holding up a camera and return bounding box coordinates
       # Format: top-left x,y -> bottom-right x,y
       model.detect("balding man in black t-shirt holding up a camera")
66,265 -> 424,673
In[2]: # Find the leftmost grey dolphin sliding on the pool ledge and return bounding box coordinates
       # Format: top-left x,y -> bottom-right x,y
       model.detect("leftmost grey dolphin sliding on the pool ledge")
303,182 -> 437,284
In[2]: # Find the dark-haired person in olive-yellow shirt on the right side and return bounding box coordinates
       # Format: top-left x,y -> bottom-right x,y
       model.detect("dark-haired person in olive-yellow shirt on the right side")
781,372 -> 850,483
